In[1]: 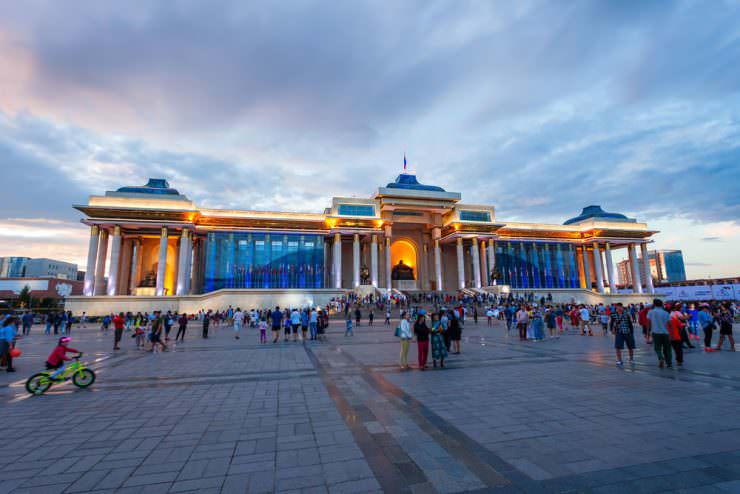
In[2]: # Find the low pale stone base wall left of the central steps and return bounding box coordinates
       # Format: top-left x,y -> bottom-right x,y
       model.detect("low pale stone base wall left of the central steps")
64,289 -> 345,316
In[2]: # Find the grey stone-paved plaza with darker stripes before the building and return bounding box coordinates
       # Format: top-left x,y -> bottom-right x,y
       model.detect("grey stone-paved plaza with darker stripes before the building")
0,314 -> 740,494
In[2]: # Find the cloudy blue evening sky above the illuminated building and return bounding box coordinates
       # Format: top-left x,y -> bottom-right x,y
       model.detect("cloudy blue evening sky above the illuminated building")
0,0 -> 740,278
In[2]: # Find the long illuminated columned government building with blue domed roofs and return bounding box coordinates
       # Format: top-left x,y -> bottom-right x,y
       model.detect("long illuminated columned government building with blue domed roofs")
68,172 -> 656,313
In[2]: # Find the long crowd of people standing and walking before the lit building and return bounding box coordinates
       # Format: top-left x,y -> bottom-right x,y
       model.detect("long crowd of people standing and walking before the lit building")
0,294 -> 740,372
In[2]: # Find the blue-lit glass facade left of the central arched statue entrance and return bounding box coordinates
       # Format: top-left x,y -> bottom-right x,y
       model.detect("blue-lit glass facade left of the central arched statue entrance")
204,232 -> 324,292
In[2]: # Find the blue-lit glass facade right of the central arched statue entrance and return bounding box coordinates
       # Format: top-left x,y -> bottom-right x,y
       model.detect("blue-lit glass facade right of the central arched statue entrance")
495,241 -> 579,288
